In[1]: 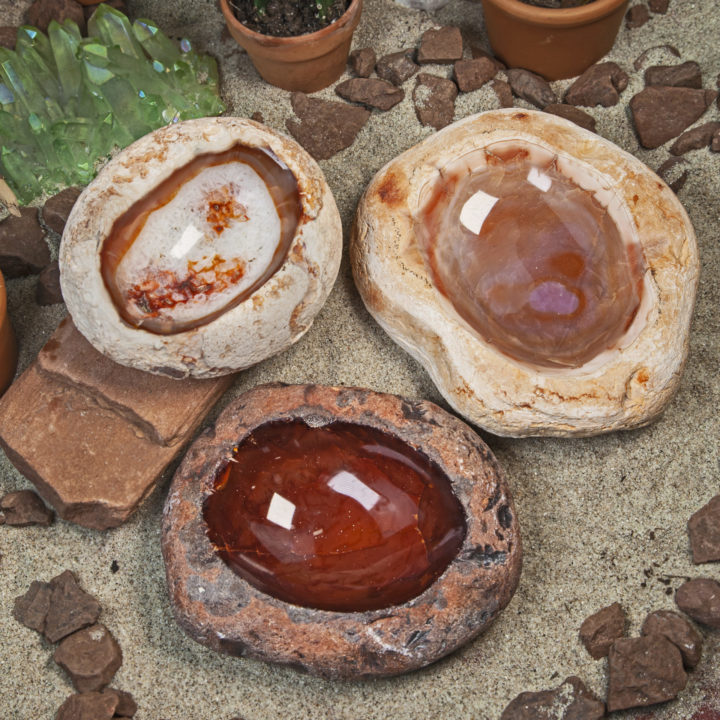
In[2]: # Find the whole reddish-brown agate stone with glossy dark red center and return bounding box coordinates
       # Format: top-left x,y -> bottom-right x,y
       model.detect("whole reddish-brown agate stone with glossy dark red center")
162,385 -> 522,678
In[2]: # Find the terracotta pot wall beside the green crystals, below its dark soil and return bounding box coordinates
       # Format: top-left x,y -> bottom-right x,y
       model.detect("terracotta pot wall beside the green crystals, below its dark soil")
220,0 -> 362,92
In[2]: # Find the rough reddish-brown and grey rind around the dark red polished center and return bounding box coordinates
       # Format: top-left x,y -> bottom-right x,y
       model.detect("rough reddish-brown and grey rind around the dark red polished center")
162,383 -> 522,678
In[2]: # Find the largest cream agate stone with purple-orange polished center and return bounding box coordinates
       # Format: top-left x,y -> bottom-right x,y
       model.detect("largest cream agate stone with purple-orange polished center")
351,109 -> 698,437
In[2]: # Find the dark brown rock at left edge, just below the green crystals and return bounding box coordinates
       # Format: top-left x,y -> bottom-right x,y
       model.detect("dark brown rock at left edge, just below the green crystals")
0,207 -> 50,278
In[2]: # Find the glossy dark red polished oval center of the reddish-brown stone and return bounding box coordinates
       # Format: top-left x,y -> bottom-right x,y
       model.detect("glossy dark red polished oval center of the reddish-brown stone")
203,420 -> 466,612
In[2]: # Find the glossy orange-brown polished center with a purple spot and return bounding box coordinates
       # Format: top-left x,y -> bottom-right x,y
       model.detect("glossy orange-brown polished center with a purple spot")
415,149 -> 645,368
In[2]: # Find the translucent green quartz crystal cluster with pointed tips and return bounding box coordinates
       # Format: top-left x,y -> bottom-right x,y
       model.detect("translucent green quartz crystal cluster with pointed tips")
0,5 -> 225,204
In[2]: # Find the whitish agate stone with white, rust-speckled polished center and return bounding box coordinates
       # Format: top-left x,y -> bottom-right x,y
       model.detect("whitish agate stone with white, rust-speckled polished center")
60,118 -> 342,377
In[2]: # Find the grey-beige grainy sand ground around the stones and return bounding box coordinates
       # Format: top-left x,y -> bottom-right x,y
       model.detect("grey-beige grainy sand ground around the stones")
0,0 -> 720,720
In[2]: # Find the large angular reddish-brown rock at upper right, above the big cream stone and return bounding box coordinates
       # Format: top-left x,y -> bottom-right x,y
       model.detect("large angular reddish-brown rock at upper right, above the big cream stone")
630,85 -> 717,148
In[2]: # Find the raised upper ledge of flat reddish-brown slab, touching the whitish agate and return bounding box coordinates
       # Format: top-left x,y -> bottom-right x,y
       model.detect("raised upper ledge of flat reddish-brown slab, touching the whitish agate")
38,317 -> 233,448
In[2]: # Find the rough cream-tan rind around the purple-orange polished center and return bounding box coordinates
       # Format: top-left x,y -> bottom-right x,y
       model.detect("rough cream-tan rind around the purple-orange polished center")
351,109 -> 699,437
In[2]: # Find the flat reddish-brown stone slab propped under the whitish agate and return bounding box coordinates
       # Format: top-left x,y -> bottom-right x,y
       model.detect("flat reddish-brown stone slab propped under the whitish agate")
0,320 -> 232,529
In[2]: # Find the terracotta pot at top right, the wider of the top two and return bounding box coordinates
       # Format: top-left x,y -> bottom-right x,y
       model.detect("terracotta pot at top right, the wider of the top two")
482,0 -> 628,80
